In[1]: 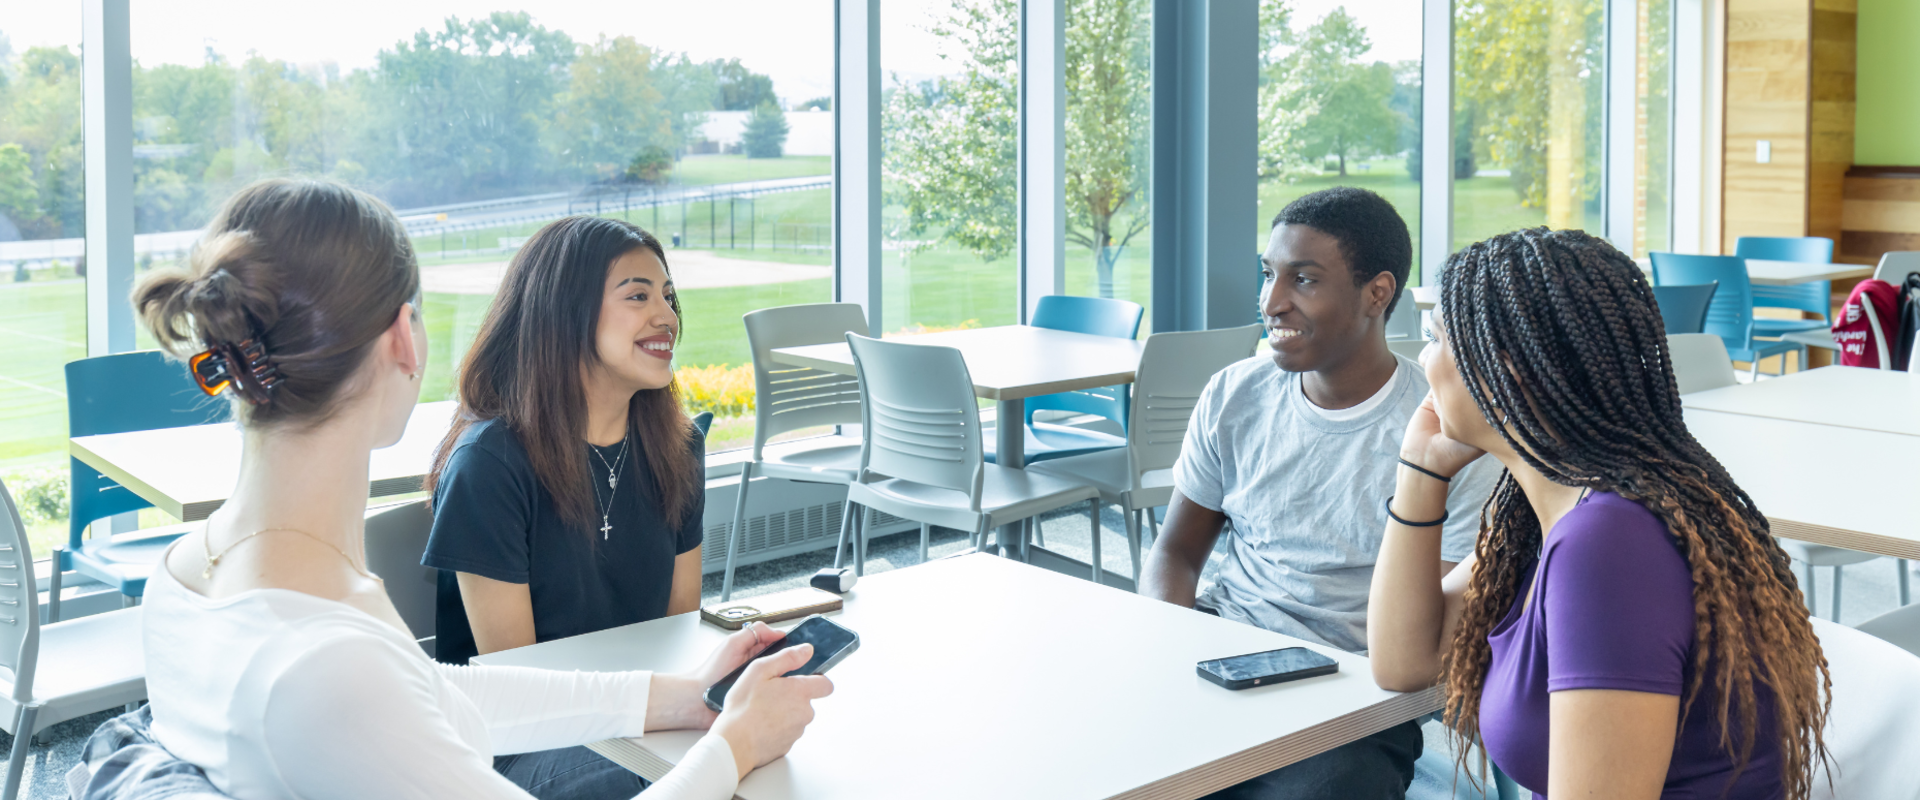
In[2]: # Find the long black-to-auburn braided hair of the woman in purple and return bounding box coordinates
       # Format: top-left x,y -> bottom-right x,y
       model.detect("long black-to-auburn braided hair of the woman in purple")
1440,228 -> 1832,800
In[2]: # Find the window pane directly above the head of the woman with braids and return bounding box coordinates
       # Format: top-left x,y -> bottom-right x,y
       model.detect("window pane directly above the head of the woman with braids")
1453,0 -> 1605,249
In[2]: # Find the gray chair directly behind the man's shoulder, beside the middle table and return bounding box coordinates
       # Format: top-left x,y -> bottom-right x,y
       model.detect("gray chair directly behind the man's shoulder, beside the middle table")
1027,322 -> 1267,585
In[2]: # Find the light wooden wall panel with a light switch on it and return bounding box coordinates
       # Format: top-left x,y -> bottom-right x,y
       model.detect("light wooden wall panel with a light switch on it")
1720,0 -> 1814,253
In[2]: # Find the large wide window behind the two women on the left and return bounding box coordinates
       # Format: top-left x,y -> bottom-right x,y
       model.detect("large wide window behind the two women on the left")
132,0 -> 833,451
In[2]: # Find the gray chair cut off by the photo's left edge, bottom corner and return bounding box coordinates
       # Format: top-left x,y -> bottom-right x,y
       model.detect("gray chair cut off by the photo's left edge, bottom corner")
0,473 -> 146,800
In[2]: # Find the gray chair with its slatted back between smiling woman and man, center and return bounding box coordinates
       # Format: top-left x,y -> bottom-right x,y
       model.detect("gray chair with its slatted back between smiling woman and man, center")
833,334 -> 1100,576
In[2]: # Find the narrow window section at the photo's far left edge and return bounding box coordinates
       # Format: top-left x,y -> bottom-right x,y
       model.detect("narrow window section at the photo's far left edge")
0,2 -> 86,556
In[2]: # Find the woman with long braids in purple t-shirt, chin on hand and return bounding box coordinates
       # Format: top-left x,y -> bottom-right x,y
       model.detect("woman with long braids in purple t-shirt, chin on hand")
1367,228 -> 1828,800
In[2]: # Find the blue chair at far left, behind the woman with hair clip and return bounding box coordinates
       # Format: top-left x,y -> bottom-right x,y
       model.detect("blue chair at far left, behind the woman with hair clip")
46,349 -> 230,620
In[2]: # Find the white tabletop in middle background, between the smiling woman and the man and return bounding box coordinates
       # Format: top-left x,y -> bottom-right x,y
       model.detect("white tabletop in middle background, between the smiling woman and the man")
774,324 -> 1144,401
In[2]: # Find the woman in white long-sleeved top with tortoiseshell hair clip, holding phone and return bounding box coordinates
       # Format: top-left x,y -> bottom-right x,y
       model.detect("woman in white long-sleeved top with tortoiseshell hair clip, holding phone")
132,180 -> 831,800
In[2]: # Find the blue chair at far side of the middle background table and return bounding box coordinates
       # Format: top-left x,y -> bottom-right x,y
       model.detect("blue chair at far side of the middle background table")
985,295 -> 1146,464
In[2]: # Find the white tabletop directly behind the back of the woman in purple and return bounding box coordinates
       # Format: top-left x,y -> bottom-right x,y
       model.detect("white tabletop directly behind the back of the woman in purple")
1686,409 -> 1920,558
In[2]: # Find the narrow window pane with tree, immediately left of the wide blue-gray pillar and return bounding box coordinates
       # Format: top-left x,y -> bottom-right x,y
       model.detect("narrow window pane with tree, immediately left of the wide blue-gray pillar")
1064,0 -> 1154,320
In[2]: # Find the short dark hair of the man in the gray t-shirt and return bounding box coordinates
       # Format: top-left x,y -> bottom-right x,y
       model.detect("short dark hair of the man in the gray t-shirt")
1267,186 -> 1413,318
